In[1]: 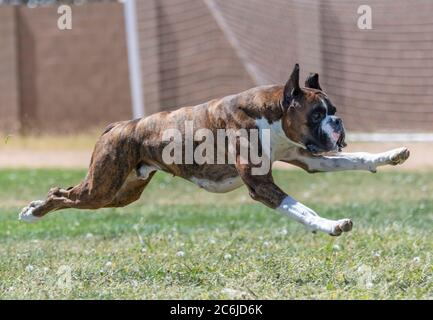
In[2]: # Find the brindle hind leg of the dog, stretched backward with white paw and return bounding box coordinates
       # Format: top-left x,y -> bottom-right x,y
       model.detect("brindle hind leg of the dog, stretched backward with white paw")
20,122 -> 141,222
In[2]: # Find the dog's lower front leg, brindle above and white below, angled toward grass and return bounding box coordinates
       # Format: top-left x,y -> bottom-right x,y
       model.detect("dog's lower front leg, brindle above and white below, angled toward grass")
237,164 -> 352,236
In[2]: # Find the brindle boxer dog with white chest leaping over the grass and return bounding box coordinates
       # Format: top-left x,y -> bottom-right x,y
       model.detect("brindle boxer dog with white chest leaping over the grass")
20,64 -> 409,236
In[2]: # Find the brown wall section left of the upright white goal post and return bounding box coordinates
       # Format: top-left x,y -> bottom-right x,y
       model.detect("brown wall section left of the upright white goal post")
0,3 -> 131,132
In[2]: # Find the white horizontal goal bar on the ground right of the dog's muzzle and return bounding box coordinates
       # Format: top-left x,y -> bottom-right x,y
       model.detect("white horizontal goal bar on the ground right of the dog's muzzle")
347,132 -> 433,142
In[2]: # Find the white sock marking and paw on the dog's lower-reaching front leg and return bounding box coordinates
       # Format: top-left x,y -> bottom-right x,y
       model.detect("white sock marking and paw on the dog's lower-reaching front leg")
277,196 -> 352,236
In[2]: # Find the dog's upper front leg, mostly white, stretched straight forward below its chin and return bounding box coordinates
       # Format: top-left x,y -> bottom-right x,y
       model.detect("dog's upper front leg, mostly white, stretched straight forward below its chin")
283,148 -> 409,172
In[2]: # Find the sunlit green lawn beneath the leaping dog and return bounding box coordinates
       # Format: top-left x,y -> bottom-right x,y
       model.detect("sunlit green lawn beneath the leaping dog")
0,170 -> 433,299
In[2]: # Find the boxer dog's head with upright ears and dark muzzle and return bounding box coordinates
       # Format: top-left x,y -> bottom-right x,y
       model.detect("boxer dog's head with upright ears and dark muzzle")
282,64 -> 346,154
